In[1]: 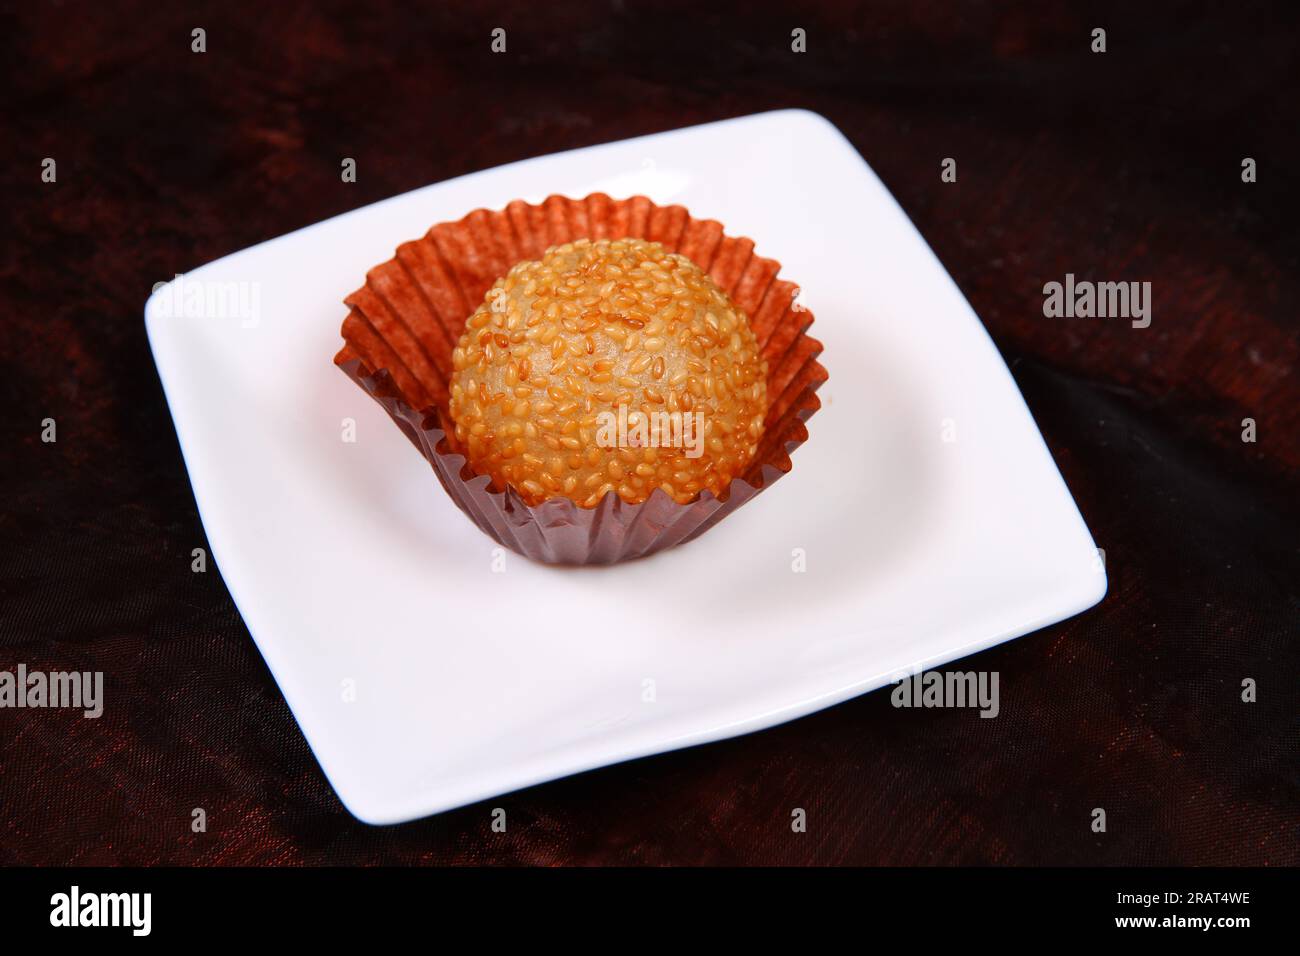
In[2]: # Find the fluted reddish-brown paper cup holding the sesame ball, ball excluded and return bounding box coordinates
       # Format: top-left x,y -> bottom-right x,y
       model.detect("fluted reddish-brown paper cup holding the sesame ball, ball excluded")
334,193 -> 827,564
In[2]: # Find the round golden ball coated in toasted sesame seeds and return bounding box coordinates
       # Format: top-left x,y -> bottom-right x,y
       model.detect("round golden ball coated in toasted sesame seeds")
450,239 -> 767,507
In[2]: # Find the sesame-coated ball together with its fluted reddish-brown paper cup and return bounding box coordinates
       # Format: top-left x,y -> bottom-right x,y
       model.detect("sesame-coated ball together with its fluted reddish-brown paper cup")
335,194 -> 827,564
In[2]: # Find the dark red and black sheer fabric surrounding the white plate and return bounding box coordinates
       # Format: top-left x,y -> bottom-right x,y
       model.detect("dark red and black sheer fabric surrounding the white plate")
0,0 -> 1300,865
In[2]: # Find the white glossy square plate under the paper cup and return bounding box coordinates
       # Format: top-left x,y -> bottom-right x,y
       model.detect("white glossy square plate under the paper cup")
146,111 -> 1106,823
